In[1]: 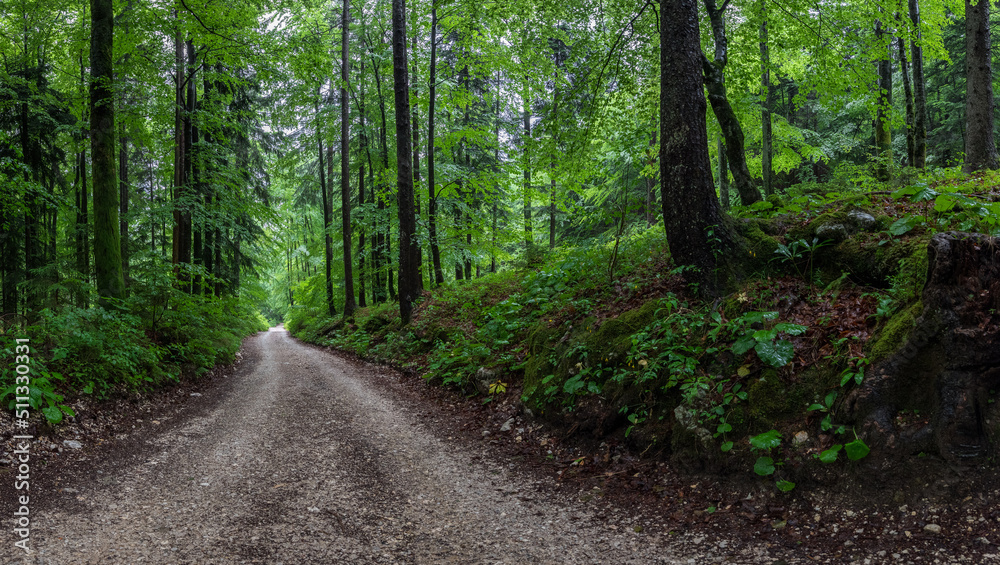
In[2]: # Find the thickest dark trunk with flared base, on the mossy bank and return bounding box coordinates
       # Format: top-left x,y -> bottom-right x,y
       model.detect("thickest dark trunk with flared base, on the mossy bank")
660,0 -> 741,295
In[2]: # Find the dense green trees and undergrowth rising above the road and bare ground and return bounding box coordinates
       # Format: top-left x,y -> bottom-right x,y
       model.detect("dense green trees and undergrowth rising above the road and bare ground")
0,0 -> 998,472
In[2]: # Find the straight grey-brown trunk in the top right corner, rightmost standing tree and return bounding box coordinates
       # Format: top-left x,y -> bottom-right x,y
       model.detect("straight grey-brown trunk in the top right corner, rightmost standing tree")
962,0 -> 1000,173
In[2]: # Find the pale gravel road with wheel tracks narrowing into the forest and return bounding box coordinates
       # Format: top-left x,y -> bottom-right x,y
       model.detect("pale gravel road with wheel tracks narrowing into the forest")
7,328 -> 788,565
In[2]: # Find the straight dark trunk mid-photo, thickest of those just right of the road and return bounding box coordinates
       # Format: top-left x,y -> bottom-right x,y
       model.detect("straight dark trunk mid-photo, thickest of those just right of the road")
392,0 -> 420,325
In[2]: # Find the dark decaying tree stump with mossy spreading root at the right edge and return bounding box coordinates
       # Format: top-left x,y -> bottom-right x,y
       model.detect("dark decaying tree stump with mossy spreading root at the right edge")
841,232 -> 1000,463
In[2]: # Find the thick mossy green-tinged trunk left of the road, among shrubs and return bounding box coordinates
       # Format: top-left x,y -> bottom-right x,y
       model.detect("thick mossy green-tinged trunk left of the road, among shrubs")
90,0 -> 125,307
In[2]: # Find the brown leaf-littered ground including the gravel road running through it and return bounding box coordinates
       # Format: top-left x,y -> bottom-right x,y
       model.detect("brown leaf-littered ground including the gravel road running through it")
0,328 -> 1000,565
